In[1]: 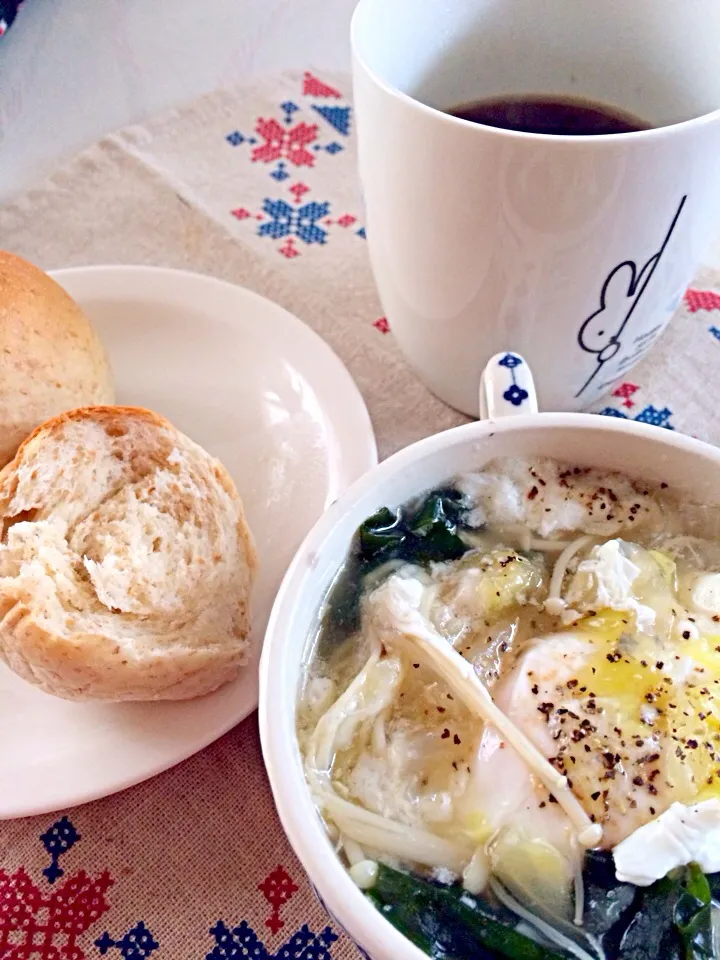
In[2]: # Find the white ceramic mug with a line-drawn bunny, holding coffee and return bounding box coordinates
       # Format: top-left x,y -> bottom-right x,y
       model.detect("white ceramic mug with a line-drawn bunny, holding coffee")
352,0 -> 720,416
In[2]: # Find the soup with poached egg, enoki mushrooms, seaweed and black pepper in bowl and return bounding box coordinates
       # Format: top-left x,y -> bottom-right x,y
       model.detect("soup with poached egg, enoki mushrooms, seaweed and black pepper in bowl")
297,459 -> 720,960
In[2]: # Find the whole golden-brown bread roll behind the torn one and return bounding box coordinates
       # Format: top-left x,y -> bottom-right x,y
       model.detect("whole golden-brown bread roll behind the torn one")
0,250 -> 115,467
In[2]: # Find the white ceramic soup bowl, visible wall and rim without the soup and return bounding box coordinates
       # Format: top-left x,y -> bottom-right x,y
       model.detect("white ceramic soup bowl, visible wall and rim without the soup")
260,370 -> 720,960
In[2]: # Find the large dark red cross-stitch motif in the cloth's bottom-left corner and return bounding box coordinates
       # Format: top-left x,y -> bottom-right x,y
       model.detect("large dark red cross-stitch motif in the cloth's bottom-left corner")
0,867 -> 113,960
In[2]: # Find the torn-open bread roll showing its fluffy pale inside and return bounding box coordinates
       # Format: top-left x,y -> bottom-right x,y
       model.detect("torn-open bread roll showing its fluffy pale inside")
0,407 -> 257,700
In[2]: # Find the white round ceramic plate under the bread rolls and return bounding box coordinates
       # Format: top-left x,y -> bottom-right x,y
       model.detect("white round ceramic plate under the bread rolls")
0,266 -> 377,818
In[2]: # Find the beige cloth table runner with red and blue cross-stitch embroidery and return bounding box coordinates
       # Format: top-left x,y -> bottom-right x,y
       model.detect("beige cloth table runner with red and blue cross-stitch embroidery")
0,70 -> 720,960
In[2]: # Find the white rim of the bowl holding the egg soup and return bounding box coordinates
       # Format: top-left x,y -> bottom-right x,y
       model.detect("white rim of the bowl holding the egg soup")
259,413 -> 720,960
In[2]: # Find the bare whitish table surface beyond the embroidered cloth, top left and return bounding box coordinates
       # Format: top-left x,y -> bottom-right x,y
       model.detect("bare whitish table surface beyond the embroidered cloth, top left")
0,0 -> 356,202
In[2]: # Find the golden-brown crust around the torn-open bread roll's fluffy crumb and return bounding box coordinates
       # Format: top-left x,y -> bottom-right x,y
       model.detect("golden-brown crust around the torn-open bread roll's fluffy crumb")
0,406 -> 257,701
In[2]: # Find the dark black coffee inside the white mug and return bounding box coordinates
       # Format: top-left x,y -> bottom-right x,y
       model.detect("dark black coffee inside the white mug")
447,94 -> 651,137
